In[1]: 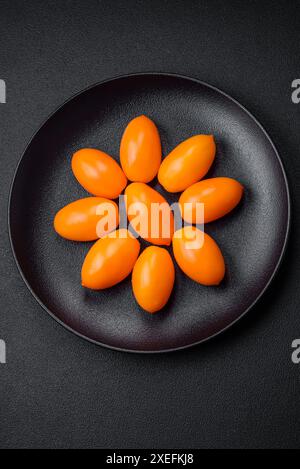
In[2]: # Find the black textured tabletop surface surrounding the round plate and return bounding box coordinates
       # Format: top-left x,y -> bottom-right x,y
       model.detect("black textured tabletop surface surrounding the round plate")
0,0 -> 300,448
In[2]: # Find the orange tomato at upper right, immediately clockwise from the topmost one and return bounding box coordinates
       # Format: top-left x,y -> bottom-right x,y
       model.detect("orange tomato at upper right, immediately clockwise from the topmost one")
158,135 -> 216,192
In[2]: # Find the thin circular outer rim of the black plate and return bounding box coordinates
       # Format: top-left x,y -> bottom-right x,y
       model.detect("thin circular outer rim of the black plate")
7,71 -> 291,355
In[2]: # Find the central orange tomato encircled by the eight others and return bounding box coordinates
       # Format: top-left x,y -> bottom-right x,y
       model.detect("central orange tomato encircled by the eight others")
125,182 -> 174,246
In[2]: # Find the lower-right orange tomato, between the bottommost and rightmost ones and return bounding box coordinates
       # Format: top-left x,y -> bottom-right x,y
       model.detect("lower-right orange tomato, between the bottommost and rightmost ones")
173,226 -> 225,285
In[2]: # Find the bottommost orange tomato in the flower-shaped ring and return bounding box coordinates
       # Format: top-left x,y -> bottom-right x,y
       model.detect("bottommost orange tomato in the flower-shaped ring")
132,246 -> 175,313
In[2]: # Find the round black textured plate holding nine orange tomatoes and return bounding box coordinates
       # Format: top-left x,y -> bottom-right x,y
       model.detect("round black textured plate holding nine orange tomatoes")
9,74 -> 290,352
